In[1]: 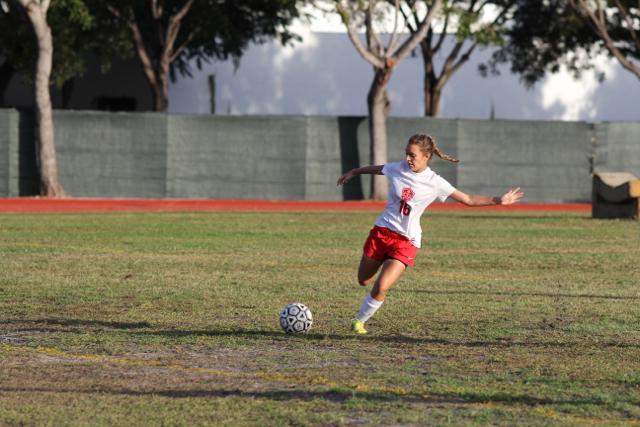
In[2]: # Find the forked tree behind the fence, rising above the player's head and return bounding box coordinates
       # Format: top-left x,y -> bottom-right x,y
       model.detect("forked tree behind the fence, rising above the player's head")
400,0 -> 515,117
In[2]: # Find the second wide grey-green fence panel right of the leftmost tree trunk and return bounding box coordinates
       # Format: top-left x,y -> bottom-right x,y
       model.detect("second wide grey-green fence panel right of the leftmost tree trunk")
167,115 -> 307,199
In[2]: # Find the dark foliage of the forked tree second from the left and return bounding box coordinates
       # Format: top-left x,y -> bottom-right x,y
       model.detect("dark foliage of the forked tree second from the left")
94,0 -> 301,84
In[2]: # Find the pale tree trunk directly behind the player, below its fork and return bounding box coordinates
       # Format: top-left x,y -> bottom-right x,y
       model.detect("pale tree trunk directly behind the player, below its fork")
367,69 -> 391,200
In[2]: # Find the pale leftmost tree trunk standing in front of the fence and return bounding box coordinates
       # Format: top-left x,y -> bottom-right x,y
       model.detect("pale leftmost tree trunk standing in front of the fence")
23,0 -> 65,197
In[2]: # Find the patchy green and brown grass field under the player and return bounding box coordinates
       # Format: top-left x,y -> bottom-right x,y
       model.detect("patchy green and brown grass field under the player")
0,210 -> 640,426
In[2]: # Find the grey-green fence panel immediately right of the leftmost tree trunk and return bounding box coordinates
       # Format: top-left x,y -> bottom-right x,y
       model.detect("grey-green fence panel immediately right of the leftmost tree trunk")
54,111 -> 168,198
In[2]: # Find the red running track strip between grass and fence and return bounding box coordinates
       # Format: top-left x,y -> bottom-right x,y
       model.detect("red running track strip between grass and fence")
0,197 -> 591,213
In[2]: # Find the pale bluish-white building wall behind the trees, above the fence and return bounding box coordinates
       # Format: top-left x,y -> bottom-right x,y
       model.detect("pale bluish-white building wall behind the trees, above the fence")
169,9 -> 640,121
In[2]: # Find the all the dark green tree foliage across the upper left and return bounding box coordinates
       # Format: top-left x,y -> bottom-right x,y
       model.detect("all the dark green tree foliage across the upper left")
0,0 -> 300,97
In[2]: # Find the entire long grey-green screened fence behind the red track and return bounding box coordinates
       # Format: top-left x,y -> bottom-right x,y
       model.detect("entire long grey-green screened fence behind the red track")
0,110 -> 640,202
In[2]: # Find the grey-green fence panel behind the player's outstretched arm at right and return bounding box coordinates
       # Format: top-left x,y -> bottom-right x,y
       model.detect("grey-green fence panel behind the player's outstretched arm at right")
458,120 -> 591,202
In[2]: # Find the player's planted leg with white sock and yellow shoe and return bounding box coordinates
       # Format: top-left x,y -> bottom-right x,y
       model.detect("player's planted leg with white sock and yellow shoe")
351,258 -> 407,335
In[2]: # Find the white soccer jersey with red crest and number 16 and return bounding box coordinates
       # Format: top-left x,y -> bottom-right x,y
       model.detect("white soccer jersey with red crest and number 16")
375,161 -> 456,248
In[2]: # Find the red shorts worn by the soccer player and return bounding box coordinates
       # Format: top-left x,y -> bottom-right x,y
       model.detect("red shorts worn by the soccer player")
363,225 -> 418,267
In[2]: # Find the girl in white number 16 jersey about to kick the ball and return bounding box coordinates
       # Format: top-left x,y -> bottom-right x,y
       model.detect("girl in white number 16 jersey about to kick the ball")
338,134 -> 524,335
